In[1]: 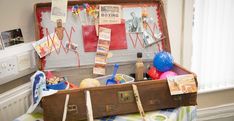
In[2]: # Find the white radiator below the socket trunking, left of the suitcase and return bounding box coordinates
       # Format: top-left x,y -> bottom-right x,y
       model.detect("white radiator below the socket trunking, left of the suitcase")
0,82 -> 31,121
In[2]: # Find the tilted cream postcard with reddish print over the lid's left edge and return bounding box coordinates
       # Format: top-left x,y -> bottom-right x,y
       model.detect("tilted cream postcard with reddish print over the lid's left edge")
32,33 -> 61,58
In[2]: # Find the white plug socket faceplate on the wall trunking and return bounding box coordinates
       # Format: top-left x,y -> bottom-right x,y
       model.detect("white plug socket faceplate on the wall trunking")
0,57 -> 18,79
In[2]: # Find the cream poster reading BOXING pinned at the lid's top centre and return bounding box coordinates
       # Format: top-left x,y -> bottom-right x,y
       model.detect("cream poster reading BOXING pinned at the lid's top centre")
99,5 -> 121,25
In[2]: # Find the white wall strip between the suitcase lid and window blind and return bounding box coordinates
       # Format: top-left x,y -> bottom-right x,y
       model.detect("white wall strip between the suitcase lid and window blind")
166,0 -> 194,69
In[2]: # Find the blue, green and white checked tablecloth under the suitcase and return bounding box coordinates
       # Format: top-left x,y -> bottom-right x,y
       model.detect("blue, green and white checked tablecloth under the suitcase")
14,106 -> 197,121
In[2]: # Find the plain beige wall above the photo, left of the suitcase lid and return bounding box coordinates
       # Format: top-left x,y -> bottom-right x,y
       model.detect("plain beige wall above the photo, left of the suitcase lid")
0,0 -> 51,42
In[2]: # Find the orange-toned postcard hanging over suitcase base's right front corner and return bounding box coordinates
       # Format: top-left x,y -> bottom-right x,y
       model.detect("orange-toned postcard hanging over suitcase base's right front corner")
167,74 -> 197,95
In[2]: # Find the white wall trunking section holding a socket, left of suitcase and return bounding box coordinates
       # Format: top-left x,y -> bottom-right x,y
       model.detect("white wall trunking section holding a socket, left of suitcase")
0,42 -> 37,85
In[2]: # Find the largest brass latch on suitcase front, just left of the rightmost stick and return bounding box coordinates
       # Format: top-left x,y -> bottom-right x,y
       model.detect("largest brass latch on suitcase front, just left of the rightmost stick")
118,91 -> 134,103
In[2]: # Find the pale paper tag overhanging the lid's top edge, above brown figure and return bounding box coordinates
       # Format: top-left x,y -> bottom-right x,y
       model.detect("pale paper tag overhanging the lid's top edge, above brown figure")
50,0 -> 68,23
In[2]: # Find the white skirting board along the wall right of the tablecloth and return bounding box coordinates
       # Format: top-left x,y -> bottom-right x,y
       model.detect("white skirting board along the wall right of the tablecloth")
197,103 -> 234,121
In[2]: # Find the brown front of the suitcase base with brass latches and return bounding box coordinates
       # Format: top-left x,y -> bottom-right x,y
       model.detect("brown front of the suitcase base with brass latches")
41,64 -> 197,121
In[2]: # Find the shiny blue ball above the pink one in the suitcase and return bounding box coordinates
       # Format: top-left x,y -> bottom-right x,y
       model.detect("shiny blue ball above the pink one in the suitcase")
153,51 -> 174,72
